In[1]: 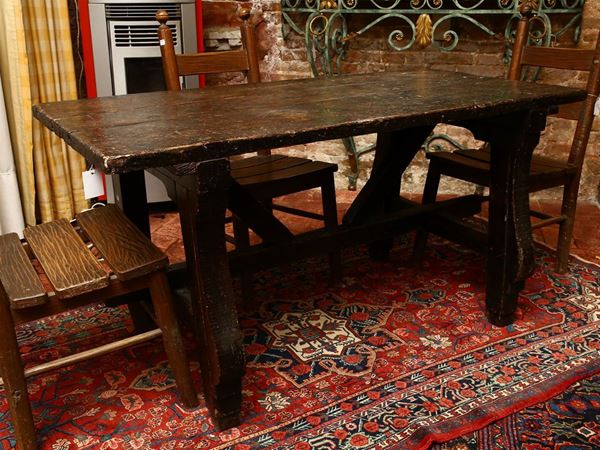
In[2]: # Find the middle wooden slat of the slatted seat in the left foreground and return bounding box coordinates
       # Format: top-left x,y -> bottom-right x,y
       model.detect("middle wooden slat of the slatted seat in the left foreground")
23,219 -> 108,298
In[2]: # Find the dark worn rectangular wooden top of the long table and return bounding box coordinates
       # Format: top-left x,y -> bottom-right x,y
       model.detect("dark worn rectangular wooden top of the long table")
33,71 -> 585,173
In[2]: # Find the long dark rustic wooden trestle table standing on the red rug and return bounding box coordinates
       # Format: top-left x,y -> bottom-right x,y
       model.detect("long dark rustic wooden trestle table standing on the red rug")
34,71 -> 585,428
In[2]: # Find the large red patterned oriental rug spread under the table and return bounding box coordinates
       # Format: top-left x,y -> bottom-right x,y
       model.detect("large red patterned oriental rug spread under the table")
0,234 -> 600,450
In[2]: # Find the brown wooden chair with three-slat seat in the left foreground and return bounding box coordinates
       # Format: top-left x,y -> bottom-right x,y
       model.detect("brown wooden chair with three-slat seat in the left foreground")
0,206 -> 198,450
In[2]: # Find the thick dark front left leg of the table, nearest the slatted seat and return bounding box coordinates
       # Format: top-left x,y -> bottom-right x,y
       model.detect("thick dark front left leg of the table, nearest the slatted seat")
177,159 -> 244,429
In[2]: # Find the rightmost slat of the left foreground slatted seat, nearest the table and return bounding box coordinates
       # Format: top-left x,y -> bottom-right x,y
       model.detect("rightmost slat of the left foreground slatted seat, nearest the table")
76,205 -> 168,280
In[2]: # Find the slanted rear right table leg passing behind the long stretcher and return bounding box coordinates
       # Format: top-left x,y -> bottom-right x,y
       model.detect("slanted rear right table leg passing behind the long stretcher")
343,126 -> 434,259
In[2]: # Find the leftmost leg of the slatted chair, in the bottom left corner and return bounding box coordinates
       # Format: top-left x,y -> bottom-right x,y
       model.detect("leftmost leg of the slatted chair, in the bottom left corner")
0,286 -> 37,450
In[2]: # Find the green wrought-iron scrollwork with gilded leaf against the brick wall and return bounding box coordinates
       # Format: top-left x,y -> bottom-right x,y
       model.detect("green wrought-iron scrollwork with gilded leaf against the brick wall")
282,0 -> 585,189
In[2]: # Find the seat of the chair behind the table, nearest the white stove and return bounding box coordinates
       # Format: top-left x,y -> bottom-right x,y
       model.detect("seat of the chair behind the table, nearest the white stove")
167,155 -> 337,199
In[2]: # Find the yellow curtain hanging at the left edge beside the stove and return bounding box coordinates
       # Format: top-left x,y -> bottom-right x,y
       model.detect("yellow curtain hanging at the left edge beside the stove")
0,0 -> 87,225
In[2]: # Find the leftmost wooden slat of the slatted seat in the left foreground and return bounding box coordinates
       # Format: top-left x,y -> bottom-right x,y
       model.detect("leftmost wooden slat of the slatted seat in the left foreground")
0,233 -> 47,309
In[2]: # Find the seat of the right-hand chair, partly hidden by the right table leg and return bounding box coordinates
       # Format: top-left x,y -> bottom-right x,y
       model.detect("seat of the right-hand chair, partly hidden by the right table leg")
427,149 -> 577,192
